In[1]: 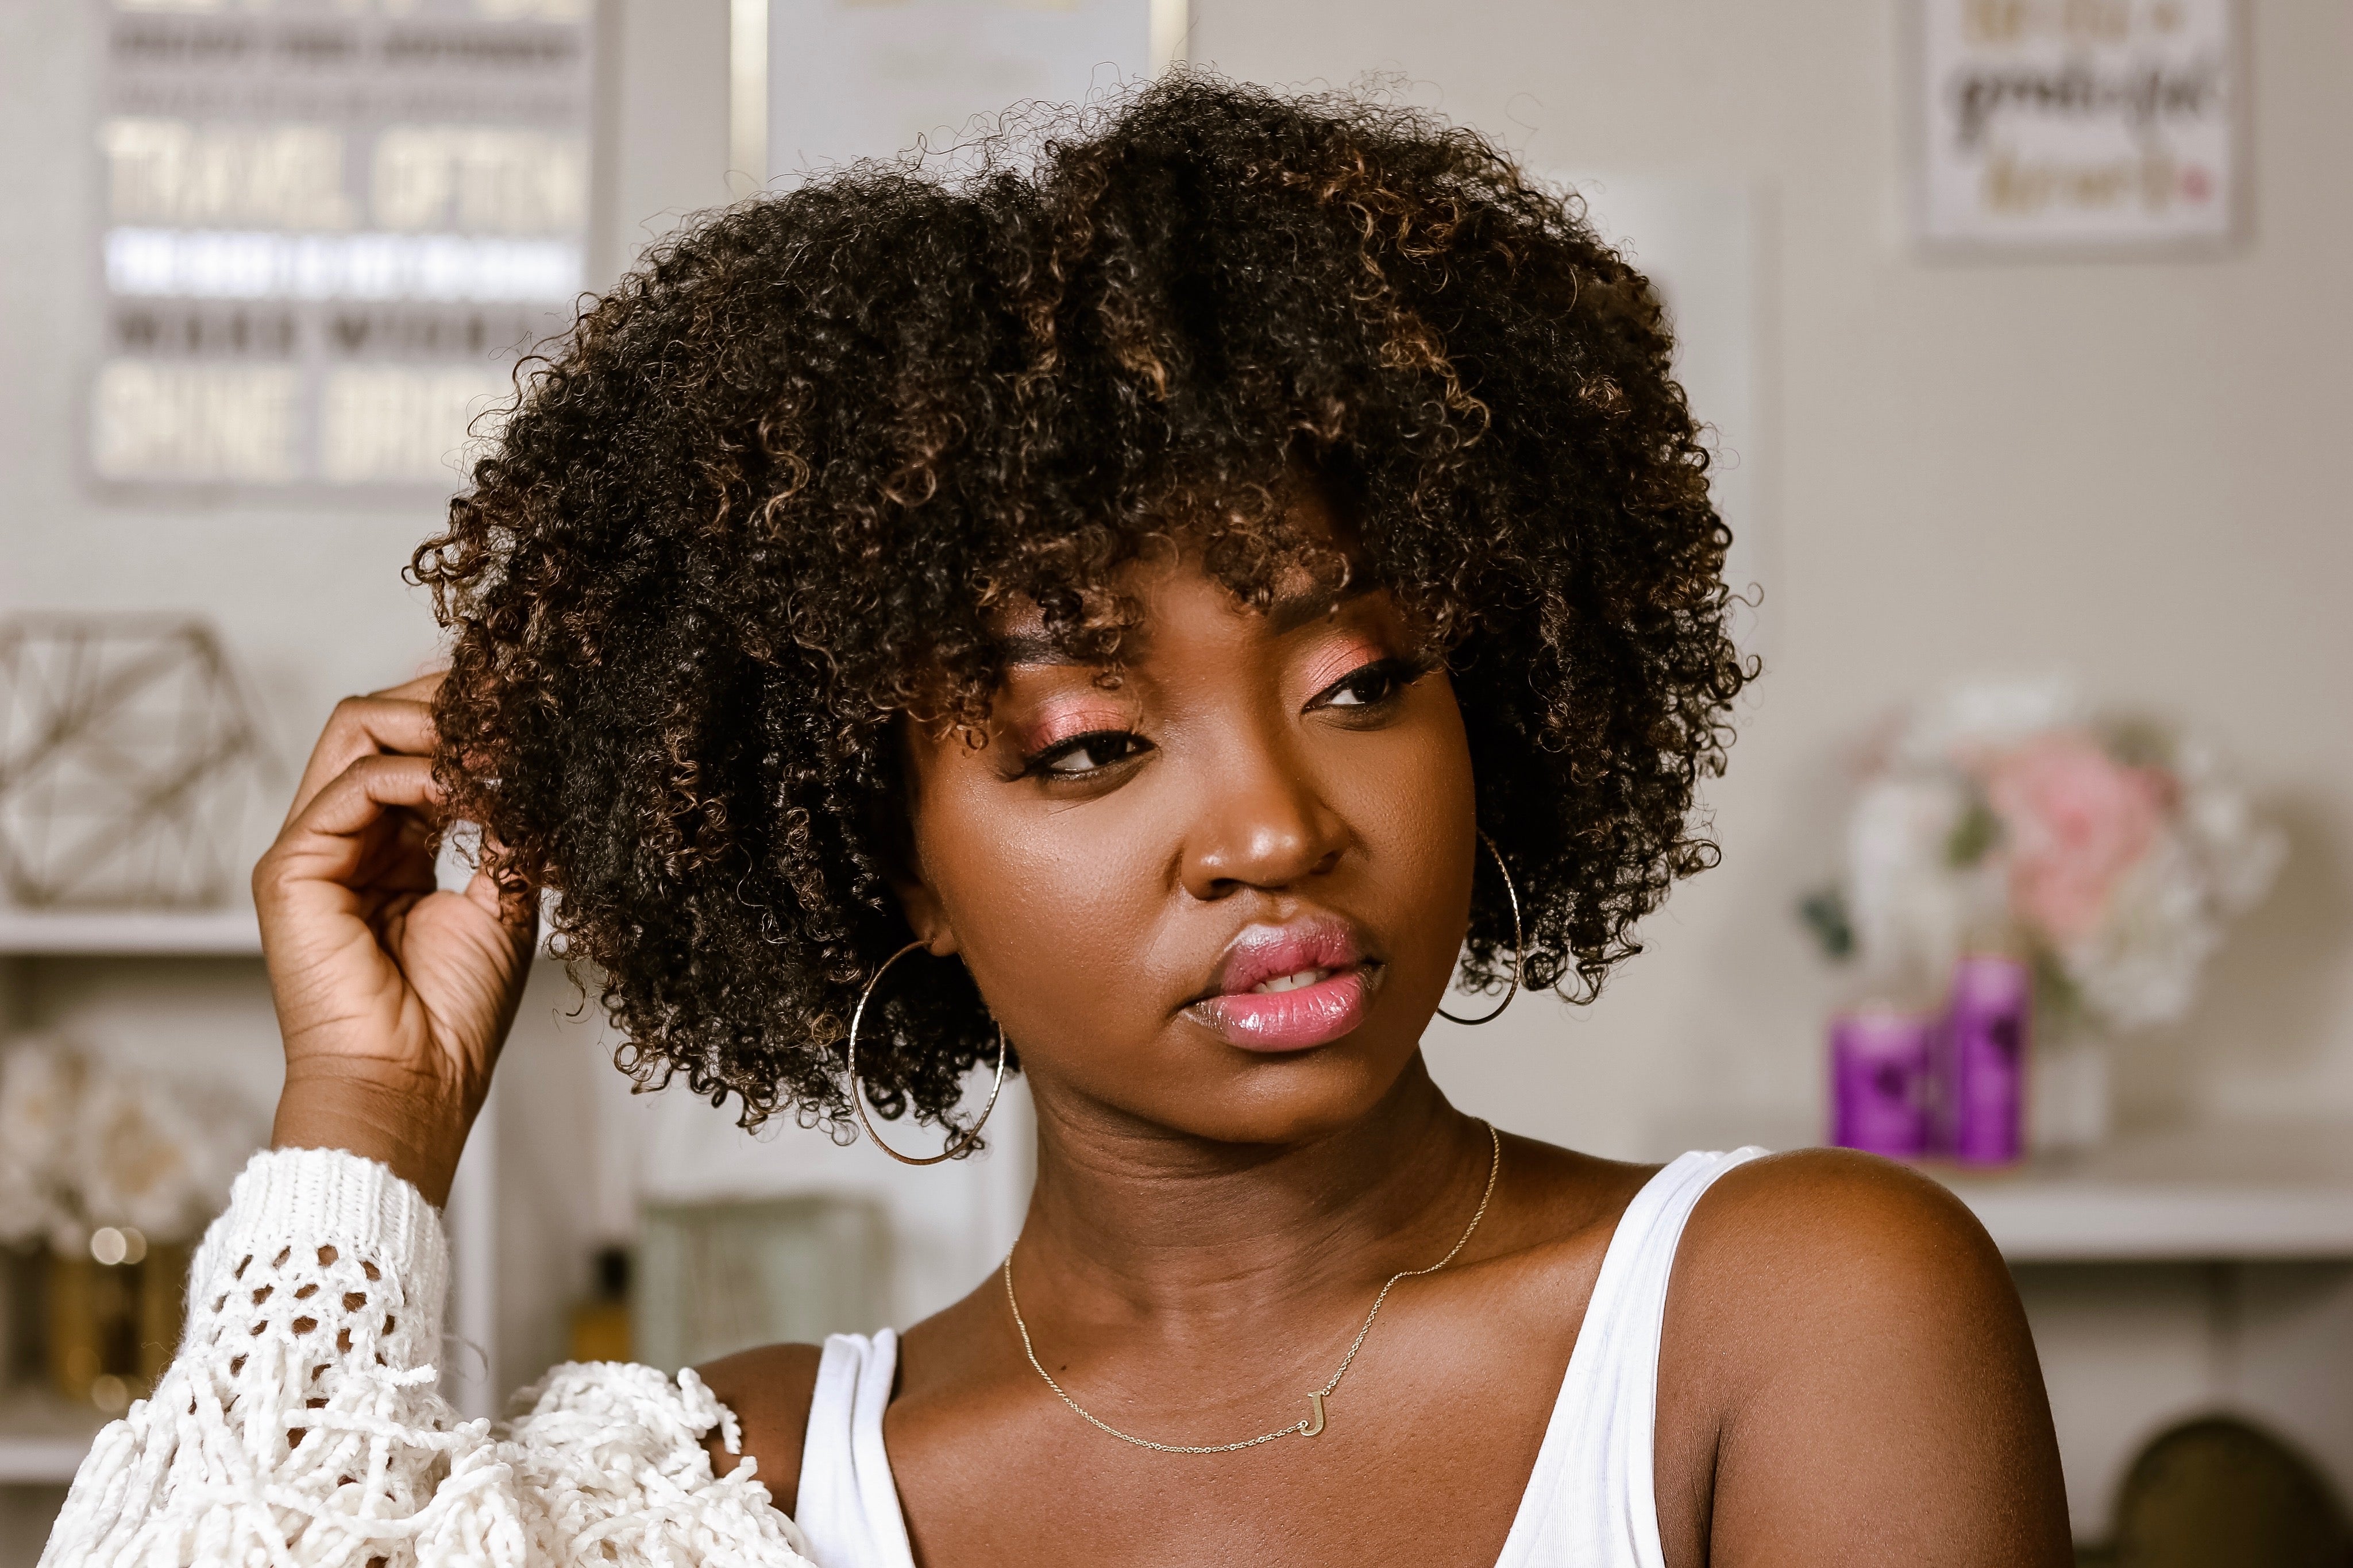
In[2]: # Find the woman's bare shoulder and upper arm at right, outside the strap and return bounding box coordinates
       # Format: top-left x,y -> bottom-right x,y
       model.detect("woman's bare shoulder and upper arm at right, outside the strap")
1659,1149 -> 2070,1563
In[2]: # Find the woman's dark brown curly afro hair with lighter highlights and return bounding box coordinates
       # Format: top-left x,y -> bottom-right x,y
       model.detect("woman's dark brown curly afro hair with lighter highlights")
412,71 -> 1753,1131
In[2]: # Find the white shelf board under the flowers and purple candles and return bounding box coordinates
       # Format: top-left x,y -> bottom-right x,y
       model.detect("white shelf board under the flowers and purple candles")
1930,1126 -> 2353,1262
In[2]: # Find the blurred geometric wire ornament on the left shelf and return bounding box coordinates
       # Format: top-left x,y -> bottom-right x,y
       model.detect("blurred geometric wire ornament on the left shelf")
0,616 -> 275,910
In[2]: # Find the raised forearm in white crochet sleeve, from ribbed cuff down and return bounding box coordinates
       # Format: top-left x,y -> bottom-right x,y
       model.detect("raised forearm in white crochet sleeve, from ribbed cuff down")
43,1149 -> 458,1568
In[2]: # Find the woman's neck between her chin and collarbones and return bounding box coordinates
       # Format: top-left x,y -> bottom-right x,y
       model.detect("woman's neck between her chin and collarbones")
1014,1056 -> 1492,1340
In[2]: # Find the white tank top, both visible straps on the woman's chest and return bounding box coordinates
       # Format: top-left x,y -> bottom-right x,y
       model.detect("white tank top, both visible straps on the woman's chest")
793,1147 -> 1765,1568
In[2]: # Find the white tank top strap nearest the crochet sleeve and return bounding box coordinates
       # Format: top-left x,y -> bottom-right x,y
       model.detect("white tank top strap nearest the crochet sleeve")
793,1328 -> 915,1568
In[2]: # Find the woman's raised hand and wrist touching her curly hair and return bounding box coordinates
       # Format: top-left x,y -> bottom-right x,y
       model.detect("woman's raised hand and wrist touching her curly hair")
254,675 -> 539,1204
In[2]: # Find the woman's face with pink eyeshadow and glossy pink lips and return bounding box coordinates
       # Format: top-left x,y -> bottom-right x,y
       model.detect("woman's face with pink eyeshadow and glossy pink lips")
901,512 -> 1478,1142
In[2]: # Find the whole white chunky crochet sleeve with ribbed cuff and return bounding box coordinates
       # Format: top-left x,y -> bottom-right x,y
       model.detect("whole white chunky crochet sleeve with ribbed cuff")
40,1149 -> 807,1568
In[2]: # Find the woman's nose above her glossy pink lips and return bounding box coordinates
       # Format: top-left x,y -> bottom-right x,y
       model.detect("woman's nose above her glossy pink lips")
1183,736 -> 1348,903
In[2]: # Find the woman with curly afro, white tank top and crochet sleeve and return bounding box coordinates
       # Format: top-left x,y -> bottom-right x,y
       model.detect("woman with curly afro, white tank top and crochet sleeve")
49,75 -> 2068,1568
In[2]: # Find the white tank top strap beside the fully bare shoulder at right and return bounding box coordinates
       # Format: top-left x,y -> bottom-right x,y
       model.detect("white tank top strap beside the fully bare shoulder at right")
1496,1147 -> 1765,1568
